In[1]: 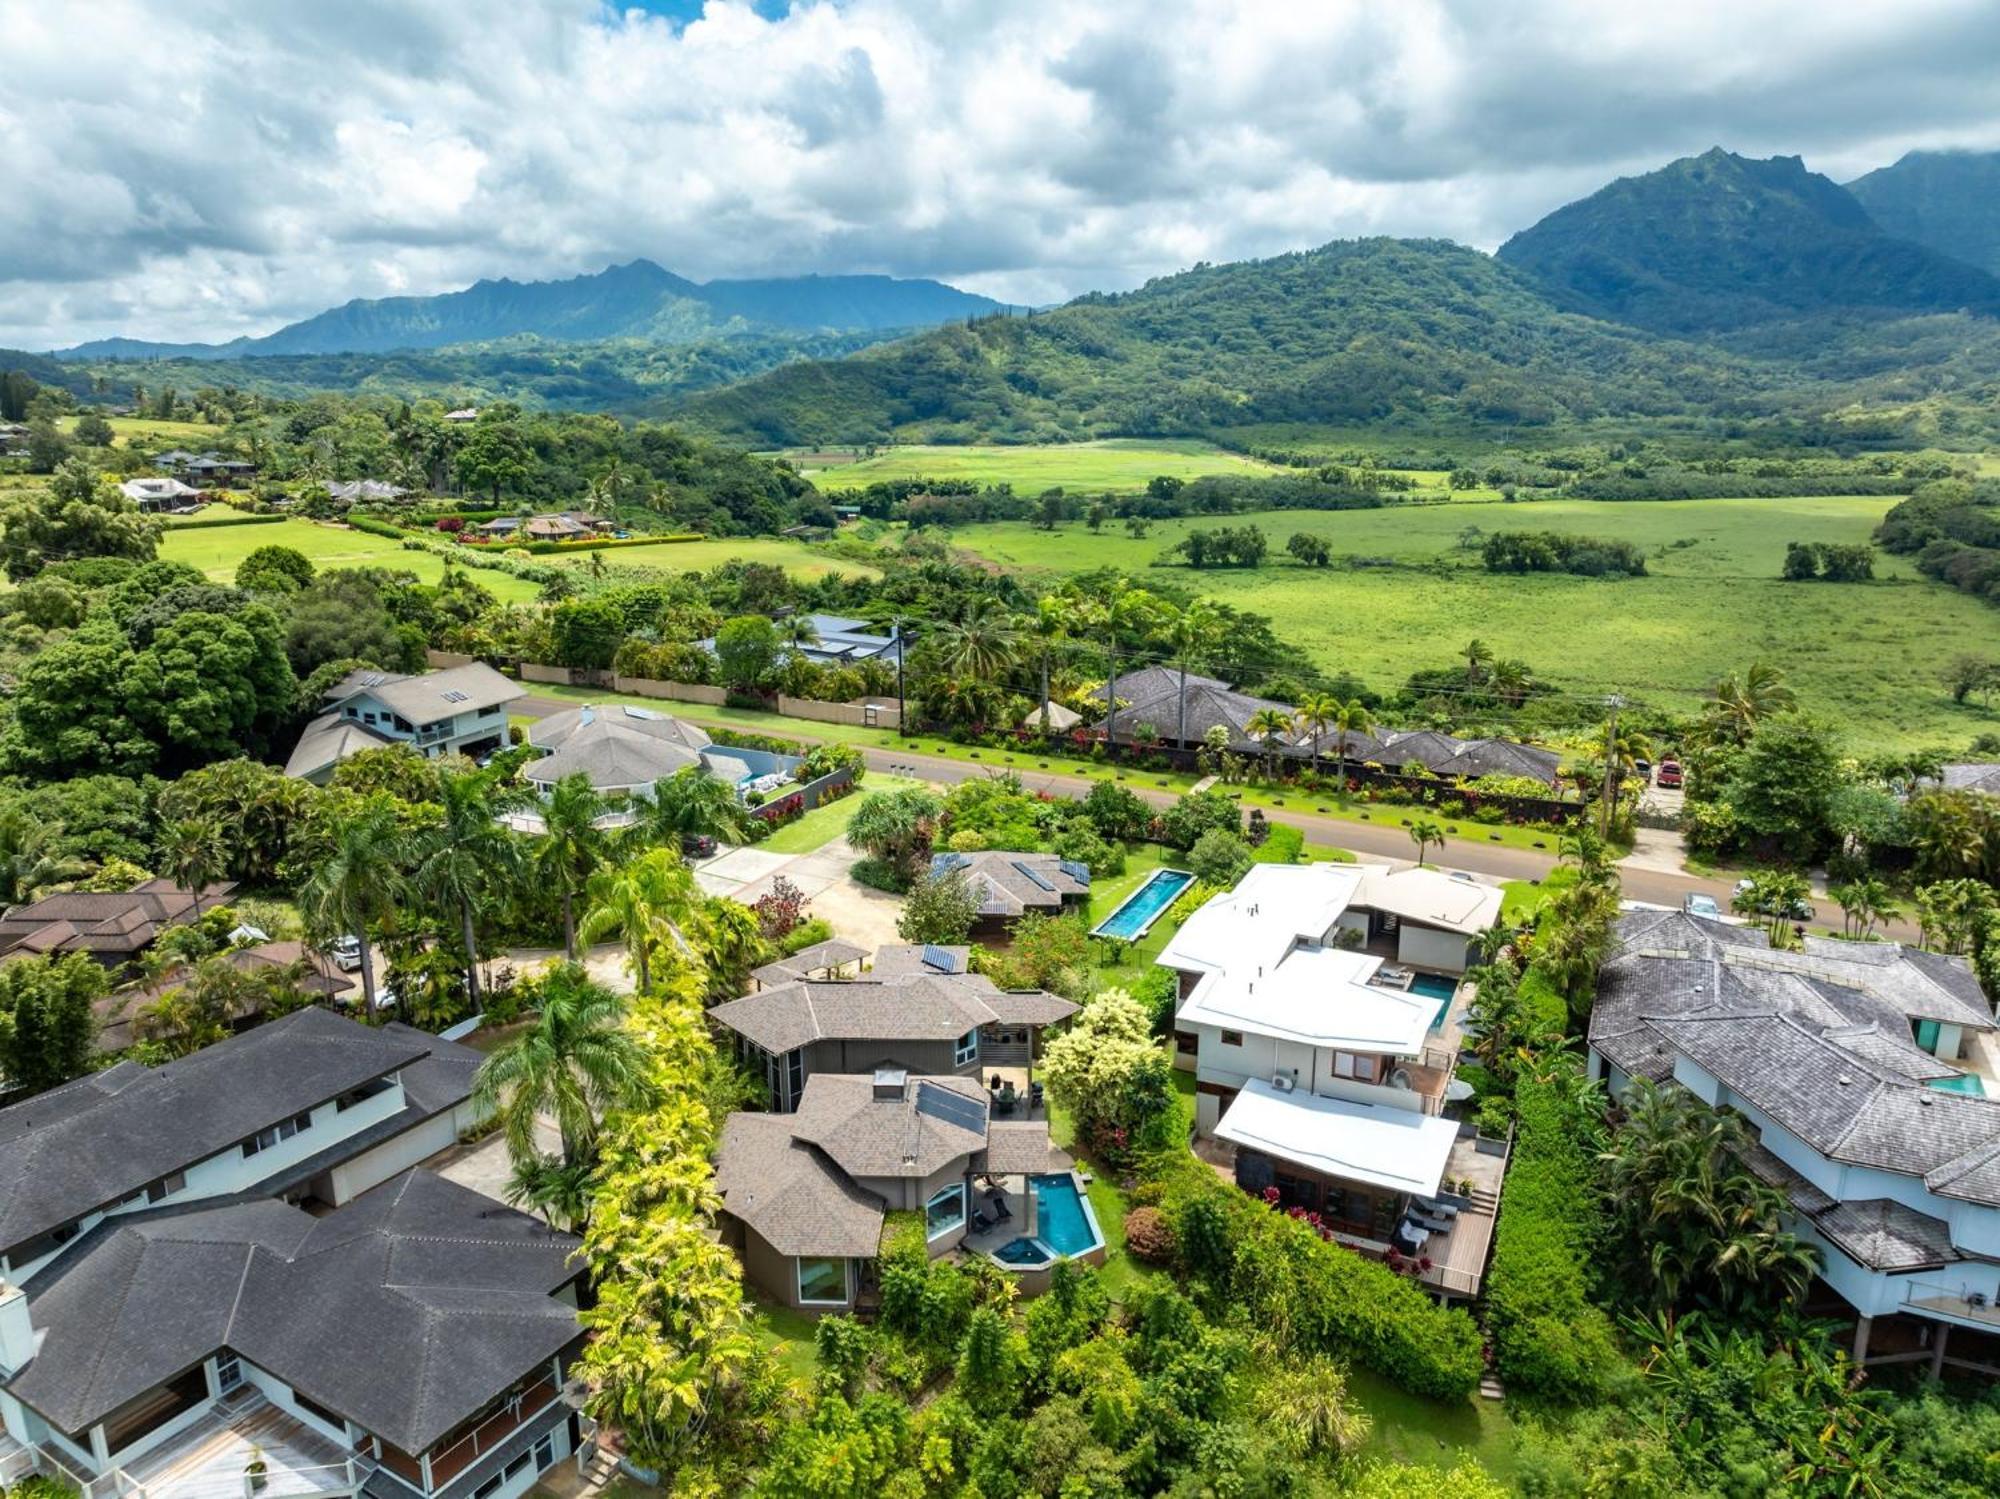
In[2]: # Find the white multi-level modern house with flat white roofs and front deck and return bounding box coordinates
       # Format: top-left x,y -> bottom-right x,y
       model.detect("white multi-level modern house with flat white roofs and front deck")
1156,863 -> 1504,1295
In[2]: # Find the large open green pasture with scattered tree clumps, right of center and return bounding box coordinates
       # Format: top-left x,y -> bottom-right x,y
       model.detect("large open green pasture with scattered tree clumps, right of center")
954,498 -> 2000,750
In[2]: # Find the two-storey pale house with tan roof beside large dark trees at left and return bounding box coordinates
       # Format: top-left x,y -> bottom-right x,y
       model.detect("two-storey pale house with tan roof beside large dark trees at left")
284,662 -> 526,785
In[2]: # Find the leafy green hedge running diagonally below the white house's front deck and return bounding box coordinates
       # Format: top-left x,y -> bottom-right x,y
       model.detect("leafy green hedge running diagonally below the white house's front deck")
1144,1149 -> 1482,1399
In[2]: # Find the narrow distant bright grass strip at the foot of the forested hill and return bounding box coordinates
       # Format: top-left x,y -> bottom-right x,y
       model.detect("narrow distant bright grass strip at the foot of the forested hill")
800,438 -> 1282,494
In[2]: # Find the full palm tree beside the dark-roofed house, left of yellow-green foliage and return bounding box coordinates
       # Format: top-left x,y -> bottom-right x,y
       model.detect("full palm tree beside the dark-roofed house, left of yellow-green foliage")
472,963 -> 658,1169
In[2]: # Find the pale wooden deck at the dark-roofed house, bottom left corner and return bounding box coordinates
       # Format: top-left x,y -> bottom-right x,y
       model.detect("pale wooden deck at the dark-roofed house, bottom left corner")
126,1391 -> 368,1499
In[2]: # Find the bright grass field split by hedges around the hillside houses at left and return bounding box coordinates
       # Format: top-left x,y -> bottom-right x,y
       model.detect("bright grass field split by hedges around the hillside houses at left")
160,512 -> 870,604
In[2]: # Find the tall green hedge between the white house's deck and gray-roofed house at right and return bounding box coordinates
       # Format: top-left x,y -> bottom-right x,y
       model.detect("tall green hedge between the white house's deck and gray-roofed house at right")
1486,1063 -> 1618,1401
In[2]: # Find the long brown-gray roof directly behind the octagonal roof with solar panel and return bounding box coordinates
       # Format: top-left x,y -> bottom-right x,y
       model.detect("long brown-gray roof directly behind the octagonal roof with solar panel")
708,969 -> 1076,1051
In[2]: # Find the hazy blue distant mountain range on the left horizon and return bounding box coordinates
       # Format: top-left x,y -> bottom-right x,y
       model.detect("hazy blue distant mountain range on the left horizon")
56,260 -> 1002,360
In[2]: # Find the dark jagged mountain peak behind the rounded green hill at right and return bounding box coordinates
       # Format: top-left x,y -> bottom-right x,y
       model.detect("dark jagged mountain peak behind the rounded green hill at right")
1498,146 -> 2000,334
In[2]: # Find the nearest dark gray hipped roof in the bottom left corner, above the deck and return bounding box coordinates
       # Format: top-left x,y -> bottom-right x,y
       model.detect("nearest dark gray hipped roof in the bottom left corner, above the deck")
10,1171 -> 578,1453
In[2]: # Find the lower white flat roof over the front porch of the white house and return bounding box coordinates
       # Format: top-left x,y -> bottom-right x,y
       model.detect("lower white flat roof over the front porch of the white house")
1216,1079 -> 1458,1197
